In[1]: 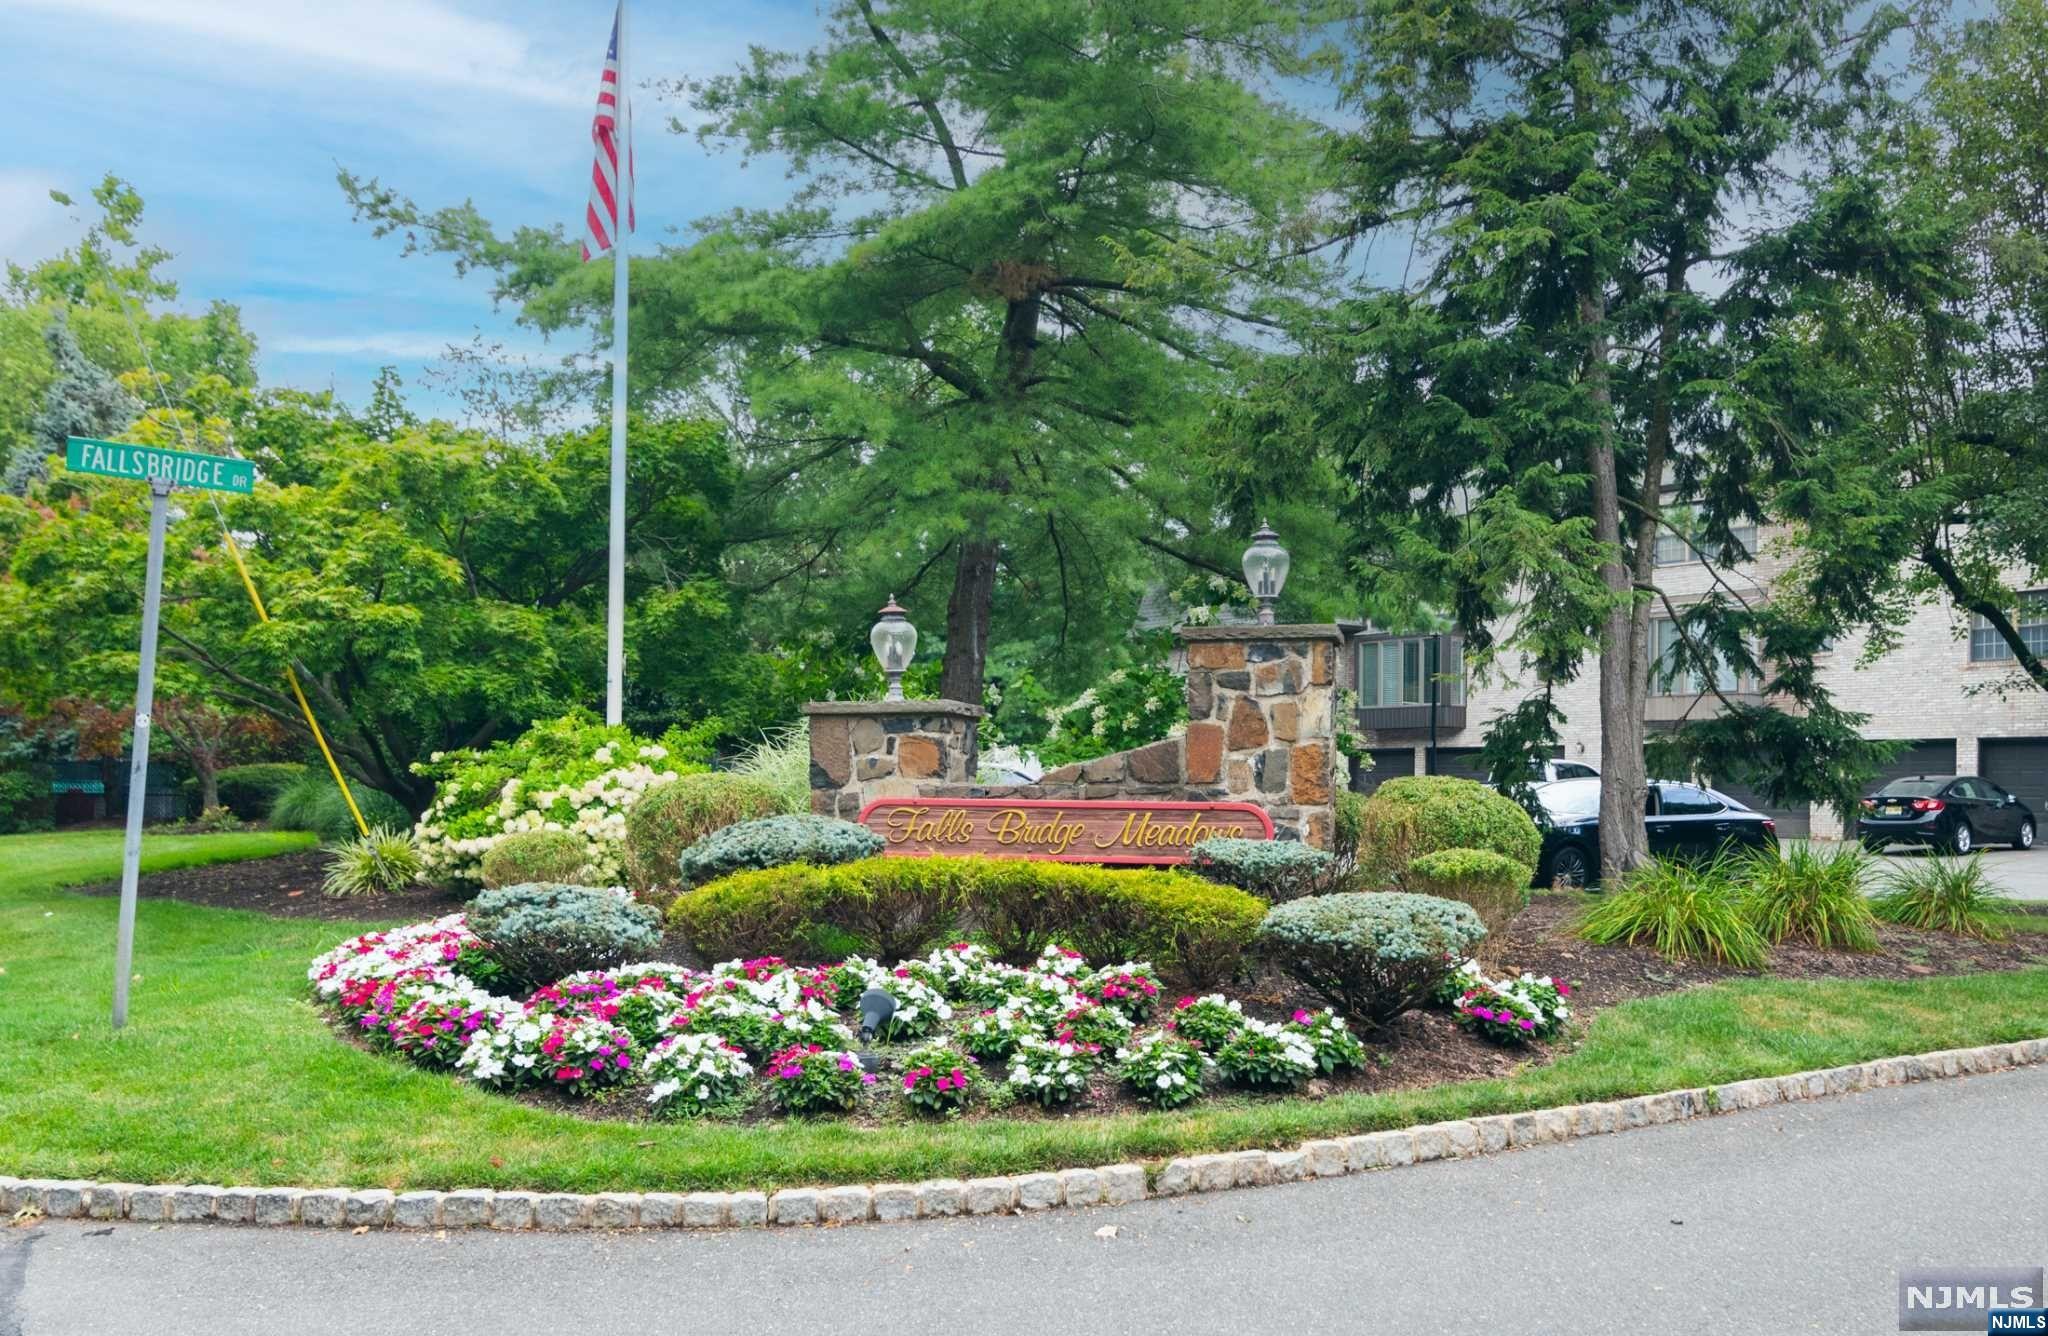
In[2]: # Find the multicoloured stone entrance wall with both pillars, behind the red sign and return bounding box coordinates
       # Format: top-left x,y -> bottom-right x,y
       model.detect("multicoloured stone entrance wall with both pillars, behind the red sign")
805,625 -> 1343,848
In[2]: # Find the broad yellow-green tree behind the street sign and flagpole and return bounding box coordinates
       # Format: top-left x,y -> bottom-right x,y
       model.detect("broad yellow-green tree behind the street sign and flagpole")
0,391 -> 748,809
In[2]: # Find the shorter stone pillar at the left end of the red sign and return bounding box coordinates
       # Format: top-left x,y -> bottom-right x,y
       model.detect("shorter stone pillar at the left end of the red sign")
803,701 -> 983,820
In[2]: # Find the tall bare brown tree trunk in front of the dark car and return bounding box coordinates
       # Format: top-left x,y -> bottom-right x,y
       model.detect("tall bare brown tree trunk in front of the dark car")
1579,291 -> 1649,883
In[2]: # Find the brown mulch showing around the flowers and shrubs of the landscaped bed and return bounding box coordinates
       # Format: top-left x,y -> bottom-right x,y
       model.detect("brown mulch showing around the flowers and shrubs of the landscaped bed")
80,850 -> 2048,1125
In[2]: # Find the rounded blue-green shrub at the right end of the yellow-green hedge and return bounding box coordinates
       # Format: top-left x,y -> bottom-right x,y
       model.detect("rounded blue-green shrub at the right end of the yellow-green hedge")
1260,891 -> 1487,1027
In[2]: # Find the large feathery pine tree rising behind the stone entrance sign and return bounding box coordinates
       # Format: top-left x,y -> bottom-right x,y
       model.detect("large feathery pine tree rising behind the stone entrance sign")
342,0 -> 1327,701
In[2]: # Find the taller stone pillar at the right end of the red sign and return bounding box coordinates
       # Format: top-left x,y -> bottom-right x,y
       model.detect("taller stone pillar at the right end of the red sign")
1178,625 -> 1343,848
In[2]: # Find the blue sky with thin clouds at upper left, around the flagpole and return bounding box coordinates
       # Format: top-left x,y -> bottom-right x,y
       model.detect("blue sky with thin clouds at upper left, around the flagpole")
0,0 -> 821,410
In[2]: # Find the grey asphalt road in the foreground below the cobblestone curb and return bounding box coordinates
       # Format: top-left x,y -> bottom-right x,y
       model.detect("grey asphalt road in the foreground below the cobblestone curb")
12,1068 -> 2048,1336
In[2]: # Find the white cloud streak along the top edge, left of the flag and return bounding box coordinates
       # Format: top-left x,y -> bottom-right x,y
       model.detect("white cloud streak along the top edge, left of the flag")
0,0 -> 598,107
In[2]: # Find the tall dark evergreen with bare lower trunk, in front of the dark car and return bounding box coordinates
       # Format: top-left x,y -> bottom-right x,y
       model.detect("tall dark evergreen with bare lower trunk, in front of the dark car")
1233,0 -> 1898,873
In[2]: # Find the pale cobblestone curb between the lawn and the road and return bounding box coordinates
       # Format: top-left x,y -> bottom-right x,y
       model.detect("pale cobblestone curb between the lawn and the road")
0,1039 -> 2048,1229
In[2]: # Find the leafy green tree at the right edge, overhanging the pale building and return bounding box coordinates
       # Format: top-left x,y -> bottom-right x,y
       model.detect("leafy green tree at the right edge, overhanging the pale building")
1778,0 -> 2048,691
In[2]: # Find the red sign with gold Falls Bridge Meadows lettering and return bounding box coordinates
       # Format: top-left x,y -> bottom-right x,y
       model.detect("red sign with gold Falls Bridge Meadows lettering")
860,797 -> 1274,863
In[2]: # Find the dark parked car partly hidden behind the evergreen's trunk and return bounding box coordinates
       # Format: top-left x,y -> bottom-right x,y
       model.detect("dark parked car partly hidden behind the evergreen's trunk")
1536,779 -> 1778,885
